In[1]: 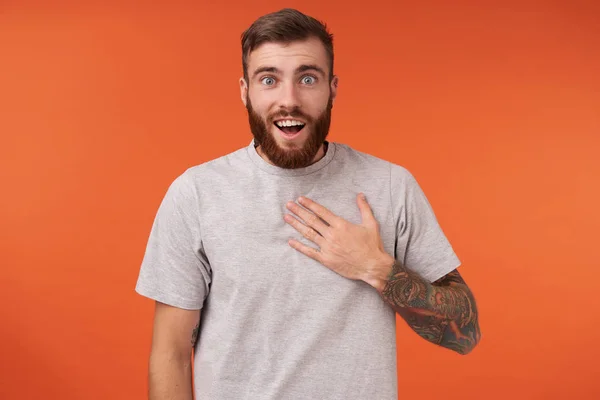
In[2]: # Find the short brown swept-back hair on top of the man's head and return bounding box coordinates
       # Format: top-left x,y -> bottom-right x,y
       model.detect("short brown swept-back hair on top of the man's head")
242,8 -> 333,81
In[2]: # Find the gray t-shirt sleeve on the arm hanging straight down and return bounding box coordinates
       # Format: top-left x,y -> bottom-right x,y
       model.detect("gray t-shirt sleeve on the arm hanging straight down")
135,173 -> 211,310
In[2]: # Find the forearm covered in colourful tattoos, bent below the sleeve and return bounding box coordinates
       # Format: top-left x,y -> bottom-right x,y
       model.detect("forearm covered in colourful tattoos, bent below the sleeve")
381,262 -> 481,354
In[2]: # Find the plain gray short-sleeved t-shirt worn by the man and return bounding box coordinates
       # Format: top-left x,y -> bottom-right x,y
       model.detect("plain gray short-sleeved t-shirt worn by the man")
136,141 -> 460,400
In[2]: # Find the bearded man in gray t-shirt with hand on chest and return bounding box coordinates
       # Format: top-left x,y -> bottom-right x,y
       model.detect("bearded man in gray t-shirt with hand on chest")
136,9 -> 480,400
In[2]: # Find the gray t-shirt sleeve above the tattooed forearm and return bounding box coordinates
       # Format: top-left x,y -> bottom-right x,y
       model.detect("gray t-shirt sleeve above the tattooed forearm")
391,165 -> 460,282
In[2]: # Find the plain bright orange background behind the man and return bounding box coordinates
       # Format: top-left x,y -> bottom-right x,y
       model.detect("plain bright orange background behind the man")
0,0 -> 600,400
